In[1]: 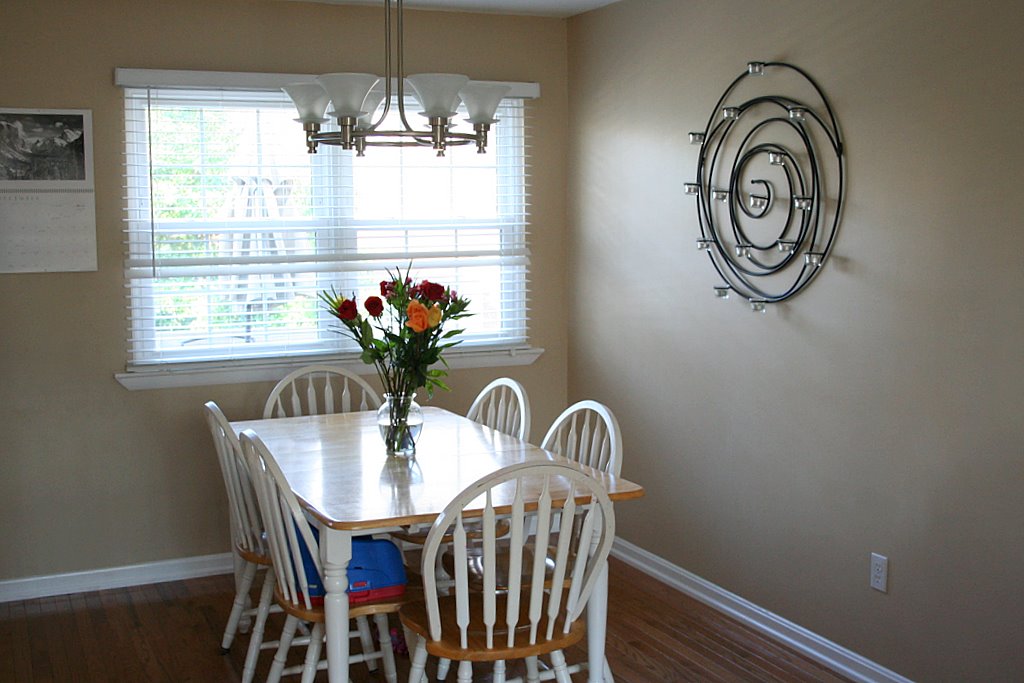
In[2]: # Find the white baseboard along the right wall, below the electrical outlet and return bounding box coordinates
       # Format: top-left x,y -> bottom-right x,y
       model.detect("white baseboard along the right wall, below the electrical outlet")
611,539 -> 912,683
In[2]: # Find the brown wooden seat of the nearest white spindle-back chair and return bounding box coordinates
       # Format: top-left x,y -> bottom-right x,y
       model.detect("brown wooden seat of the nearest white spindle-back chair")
398,596 -> 587,661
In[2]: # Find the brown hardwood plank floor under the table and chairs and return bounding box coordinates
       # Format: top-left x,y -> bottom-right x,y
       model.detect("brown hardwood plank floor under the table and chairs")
0,559 -> 847,683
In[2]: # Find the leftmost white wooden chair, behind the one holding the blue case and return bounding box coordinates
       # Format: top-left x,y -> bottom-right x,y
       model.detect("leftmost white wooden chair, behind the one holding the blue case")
204,400 -> 278,683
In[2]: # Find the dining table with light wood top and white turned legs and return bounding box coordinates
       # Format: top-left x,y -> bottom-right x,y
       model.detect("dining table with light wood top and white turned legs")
231,407 -> 644,683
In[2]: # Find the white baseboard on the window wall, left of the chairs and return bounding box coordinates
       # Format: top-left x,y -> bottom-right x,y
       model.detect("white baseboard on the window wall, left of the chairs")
0,553 -> 234,602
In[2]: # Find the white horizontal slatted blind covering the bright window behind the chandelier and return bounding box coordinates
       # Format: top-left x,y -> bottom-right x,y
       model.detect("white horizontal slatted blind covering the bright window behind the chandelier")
125,87 -> 528,372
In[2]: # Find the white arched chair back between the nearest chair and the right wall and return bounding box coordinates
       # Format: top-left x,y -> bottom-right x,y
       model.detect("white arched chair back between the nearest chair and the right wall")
541,400 -> 623,476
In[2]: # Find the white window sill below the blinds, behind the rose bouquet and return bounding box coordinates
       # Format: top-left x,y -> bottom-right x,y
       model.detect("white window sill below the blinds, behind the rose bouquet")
114,346 -> 544,391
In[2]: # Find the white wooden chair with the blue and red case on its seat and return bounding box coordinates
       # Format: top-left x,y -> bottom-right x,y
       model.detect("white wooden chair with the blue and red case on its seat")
239,429 -> 401,683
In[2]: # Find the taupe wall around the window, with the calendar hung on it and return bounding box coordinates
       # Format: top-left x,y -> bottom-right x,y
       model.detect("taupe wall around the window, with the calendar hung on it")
0,0 -> 567,580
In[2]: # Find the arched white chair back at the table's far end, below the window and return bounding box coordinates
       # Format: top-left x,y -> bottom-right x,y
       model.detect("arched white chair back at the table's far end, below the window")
263,365 -> 381,418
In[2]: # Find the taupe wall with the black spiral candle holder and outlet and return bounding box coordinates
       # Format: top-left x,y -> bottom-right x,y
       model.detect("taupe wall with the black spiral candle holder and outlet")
569,0 -> 1024,681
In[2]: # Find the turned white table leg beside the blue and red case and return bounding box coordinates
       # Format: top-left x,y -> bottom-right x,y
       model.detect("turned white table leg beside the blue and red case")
319,527 -> 352,683
